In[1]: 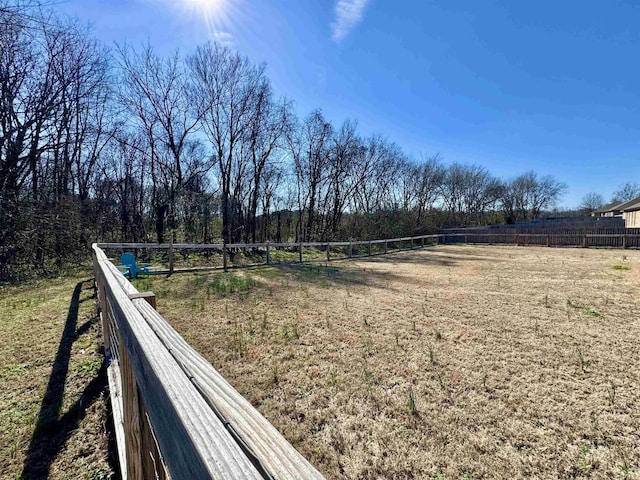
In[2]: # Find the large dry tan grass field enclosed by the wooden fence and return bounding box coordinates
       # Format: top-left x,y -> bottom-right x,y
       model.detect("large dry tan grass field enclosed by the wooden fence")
140,246 -> 640,479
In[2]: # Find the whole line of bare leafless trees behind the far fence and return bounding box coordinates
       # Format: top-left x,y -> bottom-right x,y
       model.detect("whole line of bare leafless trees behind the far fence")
0,0 -> 566,280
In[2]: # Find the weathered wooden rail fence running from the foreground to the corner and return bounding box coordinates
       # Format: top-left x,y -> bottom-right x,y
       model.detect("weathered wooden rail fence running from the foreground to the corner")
93,244 -> 324,480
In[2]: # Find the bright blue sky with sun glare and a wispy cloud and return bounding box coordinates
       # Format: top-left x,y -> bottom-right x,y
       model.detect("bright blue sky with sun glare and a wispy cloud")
59,0 -> 640,207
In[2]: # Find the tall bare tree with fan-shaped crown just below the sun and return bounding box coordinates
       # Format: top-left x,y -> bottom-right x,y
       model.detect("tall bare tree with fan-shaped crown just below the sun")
188,43 -> 272,243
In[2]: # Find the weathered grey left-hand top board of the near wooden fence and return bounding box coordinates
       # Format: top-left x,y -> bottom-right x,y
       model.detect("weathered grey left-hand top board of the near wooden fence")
94,246 -> 262,480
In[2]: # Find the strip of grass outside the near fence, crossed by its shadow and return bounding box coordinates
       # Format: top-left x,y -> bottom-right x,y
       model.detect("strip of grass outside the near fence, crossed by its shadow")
0,272 -> 113,480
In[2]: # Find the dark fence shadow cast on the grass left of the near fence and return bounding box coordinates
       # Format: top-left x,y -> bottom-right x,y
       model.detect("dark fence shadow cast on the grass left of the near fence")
20,280 -> 117,480
